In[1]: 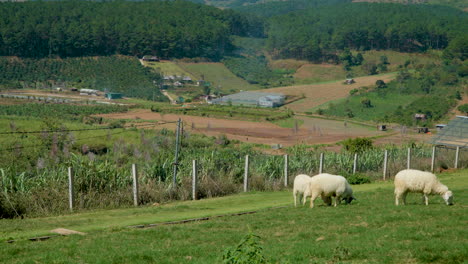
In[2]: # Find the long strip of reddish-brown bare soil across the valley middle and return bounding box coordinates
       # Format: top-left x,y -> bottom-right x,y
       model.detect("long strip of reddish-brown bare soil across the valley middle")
100,110 -> 388,146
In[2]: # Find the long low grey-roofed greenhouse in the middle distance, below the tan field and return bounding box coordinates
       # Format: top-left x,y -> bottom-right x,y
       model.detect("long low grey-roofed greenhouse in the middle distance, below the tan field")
211,92 -> 285,107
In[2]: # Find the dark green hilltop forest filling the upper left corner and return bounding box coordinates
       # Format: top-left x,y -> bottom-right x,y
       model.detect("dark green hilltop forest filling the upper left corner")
0,0 -> 263,60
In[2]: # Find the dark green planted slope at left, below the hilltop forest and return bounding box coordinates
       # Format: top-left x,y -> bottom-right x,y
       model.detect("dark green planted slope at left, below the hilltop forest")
0,56 -> 167,101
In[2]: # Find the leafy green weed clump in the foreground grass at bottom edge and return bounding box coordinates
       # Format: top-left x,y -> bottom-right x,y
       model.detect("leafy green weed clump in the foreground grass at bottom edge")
223,232 -> 269,264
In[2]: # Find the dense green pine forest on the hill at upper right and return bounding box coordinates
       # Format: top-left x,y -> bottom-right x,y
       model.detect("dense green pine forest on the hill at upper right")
267,3 -> 468,62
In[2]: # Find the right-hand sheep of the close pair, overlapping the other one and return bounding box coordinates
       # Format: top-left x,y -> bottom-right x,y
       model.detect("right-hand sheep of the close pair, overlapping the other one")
307,173 -> 356,208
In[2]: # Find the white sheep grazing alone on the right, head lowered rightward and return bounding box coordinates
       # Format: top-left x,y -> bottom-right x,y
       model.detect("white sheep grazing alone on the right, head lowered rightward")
394,170 -> 453,205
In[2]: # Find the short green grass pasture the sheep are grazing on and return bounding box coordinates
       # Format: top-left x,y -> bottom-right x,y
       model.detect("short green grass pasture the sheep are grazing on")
0,170 -> 468,263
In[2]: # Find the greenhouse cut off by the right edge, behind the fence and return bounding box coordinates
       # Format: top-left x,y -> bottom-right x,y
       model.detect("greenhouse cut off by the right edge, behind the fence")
430,116 -> 468,148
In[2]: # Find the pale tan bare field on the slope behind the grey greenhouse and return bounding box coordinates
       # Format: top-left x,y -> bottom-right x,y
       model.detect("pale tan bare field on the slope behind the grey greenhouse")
261,73 -> 396,112
